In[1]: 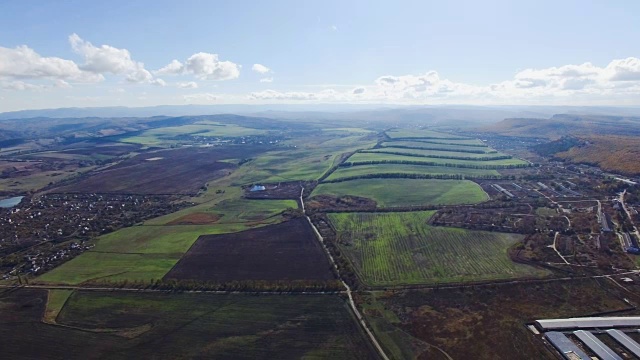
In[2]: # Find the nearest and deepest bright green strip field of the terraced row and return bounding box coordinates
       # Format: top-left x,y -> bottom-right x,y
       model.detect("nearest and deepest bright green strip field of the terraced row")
311,179 -> 488,207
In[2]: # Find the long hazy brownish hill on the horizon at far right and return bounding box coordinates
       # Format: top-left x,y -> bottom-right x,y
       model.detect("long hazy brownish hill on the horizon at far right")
481,114 -> 640,139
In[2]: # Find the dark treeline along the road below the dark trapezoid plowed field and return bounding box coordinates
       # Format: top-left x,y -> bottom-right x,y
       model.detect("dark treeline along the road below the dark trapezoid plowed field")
88,279 -> 345,293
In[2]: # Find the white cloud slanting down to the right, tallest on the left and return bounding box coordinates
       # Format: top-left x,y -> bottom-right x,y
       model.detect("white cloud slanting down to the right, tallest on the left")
69,34 -> 165,86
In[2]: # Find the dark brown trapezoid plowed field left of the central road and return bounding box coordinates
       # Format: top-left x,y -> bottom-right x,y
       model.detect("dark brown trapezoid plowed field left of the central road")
165,218 -> 334,282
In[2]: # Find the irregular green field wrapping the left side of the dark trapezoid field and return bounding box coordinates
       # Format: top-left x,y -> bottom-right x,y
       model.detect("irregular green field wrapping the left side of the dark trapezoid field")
36,199 -> 297,284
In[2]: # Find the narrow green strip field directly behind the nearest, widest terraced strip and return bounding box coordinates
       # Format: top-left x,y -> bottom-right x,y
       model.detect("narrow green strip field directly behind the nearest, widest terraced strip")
327,164 -> 500,180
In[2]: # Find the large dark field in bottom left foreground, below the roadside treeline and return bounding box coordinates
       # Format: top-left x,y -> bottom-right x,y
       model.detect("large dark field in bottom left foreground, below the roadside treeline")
0,289 -> 376,359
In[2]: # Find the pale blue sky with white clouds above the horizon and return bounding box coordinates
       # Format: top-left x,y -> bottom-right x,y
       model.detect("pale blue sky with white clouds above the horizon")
0,0 -> 640,112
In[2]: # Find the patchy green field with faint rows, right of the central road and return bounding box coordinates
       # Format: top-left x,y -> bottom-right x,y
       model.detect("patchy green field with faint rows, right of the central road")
329,211 -> 542,286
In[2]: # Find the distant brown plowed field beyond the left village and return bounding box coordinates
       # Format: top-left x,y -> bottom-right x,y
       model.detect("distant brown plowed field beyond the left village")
53,145 -> 265,195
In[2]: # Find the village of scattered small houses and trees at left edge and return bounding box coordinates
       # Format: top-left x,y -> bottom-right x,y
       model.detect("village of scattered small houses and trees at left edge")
0,194 -> 189,279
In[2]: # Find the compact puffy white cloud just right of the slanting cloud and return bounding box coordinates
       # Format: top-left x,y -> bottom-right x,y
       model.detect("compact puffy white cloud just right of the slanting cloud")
156,52 -> 240,81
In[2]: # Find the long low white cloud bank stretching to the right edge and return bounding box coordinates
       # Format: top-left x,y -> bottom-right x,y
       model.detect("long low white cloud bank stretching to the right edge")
248,58 -> 640,104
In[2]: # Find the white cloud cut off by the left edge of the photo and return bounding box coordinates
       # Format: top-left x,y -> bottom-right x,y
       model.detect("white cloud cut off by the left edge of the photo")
0,45 -> 104,82
